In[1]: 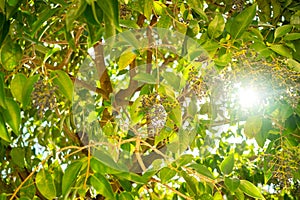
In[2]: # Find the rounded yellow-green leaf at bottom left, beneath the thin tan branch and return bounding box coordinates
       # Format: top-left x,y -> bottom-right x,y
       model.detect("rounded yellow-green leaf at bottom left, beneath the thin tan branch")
35,169 -> 56,199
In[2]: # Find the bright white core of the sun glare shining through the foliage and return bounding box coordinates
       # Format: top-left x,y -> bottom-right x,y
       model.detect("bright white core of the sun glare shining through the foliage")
238,88 -> 259,108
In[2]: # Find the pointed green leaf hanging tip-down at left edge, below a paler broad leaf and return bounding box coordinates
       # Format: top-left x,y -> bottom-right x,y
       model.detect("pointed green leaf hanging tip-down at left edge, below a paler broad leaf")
3,99 -> 21,135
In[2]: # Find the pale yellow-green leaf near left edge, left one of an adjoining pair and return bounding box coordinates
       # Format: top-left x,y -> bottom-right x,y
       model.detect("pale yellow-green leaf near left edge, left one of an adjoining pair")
10,73 -> 27,103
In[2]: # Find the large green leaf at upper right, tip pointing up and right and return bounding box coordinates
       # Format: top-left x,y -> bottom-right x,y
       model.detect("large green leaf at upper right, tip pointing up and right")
230,4 -> 256,40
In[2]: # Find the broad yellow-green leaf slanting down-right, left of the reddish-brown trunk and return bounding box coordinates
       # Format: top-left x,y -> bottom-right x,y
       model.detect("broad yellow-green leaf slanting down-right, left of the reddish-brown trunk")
51,70 -> 74,101
